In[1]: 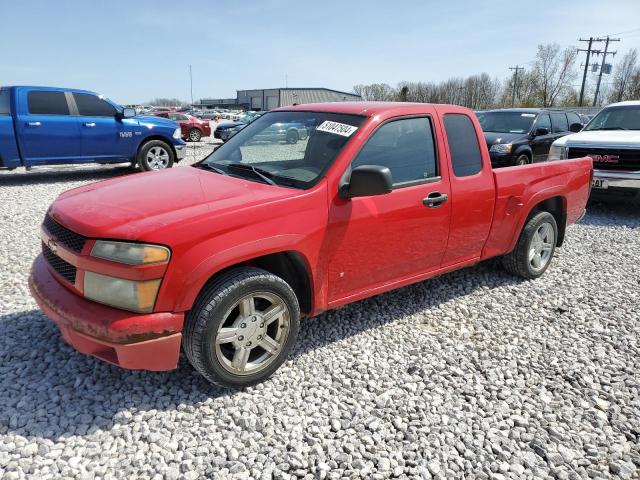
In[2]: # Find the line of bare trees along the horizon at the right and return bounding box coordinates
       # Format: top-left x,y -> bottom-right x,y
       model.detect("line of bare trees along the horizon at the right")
353,43 -> 640,110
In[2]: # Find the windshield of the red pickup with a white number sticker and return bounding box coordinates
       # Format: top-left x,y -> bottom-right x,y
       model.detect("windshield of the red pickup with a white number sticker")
201,112 -> 365,189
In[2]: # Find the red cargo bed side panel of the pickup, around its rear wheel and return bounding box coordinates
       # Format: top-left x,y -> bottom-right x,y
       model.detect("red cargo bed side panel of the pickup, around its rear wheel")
483,157 -> 593,257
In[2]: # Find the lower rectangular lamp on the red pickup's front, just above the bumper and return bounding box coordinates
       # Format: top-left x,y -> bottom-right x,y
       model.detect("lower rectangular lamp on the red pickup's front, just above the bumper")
84,272 -> 160,313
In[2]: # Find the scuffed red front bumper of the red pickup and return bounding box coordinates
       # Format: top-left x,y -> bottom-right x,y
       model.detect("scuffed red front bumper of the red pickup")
29,255 -> 184,371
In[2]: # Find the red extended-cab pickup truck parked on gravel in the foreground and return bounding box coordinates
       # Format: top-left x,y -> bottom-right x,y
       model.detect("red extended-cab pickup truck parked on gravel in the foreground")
30,102 -> 593,387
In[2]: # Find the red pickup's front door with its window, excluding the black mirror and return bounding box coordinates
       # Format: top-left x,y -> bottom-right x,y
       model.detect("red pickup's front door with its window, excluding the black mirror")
328,116 -> 451,304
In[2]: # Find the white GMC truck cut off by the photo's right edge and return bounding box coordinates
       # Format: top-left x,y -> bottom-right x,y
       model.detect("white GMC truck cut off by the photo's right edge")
549,101 -> 640,198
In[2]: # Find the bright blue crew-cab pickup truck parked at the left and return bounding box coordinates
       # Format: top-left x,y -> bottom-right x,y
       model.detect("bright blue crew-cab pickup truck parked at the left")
0,87 -> 186,170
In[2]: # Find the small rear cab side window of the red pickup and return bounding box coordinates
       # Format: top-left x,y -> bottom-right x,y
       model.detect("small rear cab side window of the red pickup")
444,113 -> 482,177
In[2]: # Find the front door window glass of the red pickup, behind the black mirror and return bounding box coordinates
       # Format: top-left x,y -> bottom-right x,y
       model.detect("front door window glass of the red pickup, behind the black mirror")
351,117 -> 437,186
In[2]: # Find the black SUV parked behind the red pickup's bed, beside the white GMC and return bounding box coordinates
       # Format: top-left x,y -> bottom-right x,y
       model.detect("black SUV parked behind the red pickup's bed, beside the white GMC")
476,108 -> 583,167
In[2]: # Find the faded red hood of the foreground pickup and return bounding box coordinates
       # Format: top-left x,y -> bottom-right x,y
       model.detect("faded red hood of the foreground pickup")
49,167 -> 301,240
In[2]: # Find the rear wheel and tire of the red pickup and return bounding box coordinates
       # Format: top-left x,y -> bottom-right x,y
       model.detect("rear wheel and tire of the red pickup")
502,212 -> 558,279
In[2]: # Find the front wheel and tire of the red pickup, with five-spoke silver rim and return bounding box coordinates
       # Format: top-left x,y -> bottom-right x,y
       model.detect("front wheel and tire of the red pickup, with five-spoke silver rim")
182,267 -> 300,388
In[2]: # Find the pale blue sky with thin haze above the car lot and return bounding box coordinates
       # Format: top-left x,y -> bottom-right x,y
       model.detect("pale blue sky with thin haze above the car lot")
0,0 -> 640,104
